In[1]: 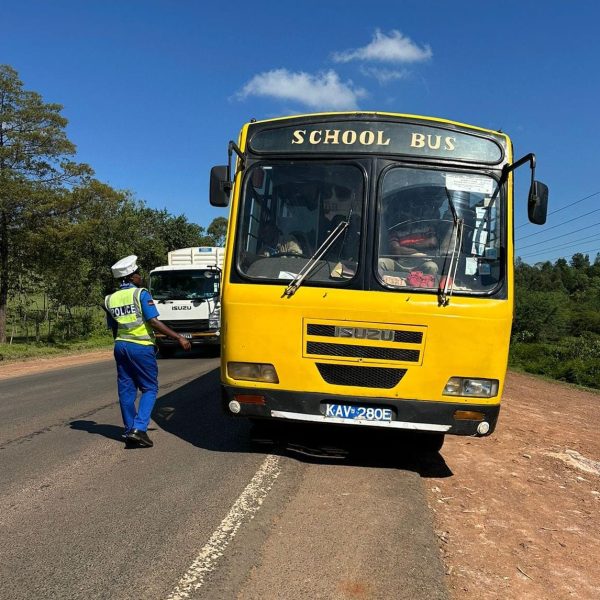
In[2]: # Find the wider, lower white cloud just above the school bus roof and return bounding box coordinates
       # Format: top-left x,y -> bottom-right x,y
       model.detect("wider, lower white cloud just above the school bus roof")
237,69 -> 367,110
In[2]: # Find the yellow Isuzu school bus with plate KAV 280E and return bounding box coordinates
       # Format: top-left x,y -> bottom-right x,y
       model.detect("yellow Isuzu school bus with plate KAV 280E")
210,112 -> 548,449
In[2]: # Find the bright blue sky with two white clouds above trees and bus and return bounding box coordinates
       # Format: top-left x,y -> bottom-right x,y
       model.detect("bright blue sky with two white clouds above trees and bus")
0,0 -> 600,262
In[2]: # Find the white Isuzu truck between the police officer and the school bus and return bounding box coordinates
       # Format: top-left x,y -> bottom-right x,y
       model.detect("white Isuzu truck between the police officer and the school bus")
149,246 -> 225,358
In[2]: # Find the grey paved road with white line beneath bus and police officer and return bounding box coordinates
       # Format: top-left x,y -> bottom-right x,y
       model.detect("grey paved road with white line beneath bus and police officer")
0,355 -> 450,600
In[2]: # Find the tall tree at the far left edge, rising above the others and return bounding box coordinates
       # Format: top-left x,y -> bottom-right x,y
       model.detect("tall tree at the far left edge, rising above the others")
0,65 -> 92,343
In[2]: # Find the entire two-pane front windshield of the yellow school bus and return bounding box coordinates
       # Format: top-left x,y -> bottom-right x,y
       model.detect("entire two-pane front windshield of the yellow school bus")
237,161 -> 504,294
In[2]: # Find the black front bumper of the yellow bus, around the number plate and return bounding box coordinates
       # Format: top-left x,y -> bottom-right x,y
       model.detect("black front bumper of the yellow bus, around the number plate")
221,384 -> 500,437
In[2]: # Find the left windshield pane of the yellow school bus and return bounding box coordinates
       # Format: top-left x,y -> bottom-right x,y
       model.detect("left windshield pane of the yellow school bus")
237,163 -> 363,285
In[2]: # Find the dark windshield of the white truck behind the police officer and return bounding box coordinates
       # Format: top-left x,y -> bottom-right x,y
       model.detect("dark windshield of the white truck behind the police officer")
150,269 -> 220,300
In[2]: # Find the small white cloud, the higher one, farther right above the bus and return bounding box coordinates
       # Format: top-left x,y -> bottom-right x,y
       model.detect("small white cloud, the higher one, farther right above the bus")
333,29 -> 433,63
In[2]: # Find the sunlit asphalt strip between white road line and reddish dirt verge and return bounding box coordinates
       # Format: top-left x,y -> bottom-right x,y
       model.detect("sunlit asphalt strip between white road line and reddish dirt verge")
237,464 -> 448,600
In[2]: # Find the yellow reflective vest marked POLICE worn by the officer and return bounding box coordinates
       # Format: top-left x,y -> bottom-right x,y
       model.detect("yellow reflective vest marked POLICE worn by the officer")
104,288 -> 154,346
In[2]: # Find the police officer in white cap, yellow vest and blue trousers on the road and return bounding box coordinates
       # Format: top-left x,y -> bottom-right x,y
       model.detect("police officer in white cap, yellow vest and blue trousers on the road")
104,255 -> 191,448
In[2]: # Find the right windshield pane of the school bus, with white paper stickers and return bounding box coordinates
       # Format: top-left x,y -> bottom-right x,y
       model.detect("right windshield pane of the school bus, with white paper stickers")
377,168 -> 503,293
